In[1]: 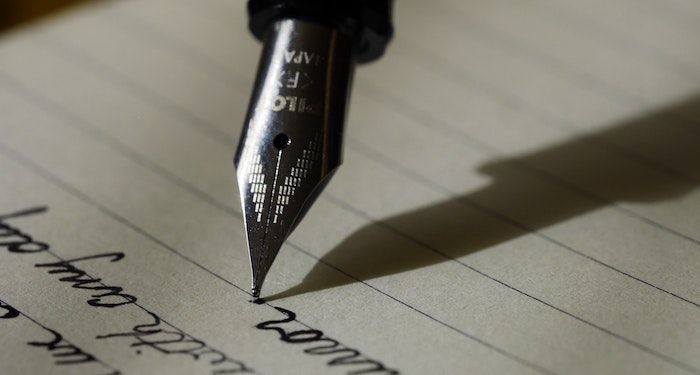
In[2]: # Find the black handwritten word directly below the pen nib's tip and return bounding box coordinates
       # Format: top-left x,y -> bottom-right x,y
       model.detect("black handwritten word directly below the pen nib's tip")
256,307 -> 399,375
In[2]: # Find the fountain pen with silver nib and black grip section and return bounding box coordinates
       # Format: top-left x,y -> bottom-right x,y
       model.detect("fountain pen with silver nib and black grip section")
234,0 -> 393,298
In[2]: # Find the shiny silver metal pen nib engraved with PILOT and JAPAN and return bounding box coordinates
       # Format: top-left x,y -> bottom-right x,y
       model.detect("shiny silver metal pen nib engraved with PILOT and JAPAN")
235,19 -> 354,297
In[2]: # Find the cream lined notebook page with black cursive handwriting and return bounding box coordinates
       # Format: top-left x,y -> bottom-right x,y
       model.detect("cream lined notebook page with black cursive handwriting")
0,0 -> 700,374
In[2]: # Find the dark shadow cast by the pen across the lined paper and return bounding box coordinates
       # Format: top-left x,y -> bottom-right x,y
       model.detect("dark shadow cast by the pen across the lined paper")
266,96 -> 700,300
